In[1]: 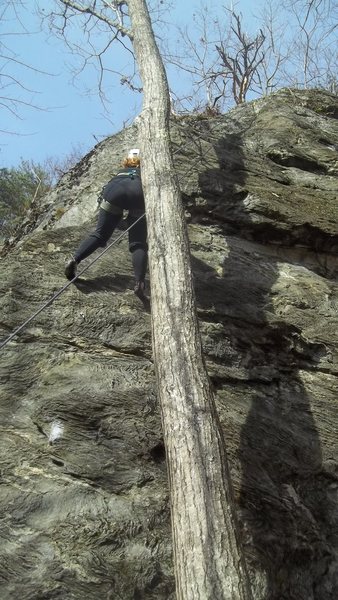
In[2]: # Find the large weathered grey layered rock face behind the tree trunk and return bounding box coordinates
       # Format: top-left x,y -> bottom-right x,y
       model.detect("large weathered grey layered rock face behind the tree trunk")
0,90 -> 338,600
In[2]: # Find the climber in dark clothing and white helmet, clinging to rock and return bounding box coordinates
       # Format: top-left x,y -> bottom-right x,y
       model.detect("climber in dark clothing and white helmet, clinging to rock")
65,148 -> 148,298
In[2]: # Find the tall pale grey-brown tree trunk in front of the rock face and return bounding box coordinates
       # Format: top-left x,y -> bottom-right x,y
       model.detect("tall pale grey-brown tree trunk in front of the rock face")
128,0 -> 251,600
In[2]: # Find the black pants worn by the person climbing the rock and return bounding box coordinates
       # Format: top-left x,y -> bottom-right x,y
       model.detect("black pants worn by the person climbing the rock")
74,208 -> 148,281
